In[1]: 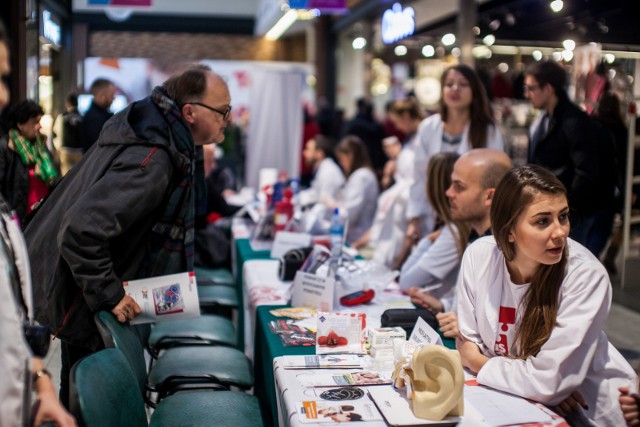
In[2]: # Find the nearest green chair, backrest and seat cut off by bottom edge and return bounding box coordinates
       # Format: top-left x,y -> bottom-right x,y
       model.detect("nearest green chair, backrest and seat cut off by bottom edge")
70,348 -> 263,427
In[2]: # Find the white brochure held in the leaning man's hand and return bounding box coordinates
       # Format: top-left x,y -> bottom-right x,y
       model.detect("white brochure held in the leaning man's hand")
123,272 -> 200,325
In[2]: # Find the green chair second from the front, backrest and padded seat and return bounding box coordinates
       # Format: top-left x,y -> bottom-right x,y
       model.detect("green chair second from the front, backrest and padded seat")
95,311 -> 253,406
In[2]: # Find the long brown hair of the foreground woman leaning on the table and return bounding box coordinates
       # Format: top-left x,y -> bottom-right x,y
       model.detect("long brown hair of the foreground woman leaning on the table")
491,165 -> 568,359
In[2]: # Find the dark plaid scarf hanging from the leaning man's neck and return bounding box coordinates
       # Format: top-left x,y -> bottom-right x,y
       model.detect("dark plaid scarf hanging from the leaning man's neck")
138,86 -> 204,277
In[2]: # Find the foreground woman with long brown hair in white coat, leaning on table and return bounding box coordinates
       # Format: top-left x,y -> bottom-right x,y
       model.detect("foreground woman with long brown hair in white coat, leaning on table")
458,165 -> 636,426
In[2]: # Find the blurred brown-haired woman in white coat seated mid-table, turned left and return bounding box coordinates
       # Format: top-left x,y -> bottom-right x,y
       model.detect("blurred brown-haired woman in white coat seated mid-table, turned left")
336,135 -> 379,243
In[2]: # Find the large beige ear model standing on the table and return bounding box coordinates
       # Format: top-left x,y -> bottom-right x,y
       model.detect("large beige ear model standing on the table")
411,345 -> 464,420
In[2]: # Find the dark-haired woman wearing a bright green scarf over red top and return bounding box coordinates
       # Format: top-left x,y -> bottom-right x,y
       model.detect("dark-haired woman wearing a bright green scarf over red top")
0,100 -> 60,222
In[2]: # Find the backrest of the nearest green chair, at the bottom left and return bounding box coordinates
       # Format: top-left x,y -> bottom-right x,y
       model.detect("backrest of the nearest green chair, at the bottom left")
70,348 -> 148,427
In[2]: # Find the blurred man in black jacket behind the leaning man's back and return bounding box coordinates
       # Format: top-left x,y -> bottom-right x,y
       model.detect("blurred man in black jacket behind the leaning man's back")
80,79 -> 116,153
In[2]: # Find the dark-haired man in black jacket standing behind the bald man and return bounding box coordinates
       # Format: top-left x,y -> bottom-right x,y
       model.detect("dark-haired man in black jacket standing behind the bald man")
524,61 -> 616,251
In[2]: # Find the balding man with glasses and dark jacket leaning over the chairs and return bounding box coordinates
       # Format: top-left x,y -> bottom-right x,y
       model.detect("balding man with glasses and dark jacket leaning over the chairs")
25,65 -> 231,403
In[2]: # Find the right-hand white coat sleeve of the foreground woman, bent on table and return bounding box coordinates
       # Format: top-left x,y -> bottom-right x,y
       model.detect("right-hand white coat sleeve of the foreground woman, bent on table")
478,259 -> 613,405
